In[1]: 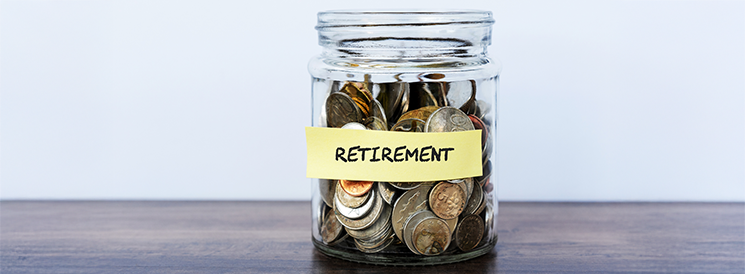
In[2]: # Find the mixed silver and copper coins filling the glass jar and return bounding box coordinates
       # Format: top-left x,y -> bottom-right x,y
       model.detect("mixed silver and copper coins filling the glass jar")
319,81 -> 493,256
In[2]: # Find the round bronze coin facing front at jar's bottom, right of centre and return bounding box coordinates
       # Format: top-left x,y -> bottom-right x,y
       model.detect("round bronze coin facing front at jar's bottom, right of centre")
411,214 -> 451,256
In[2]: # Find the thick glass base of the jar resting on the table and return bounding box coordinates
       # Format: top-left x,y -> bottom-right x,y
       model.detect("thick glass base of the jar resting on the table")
312,235 -> 498,266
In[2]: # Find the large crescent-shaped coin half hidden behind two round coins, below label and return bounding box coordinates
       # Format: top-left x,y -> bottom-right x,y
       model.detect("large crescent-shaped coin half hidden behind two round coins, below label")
391,184 -> 432,240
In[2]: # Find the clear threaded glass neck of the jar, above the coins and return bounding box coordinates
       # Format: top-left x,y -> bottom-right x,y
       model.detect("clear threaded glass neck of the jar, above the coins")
316,11 -> 494,61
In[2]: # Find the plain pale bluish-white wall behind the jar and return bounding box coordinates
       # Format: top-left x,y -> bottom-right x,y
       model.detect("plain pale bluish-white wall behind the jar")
0,0 -> 745,201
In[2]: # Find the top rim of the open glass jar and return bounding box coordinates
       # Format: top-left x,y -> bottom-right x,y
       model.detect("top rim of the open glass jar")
316,10 -> 494,31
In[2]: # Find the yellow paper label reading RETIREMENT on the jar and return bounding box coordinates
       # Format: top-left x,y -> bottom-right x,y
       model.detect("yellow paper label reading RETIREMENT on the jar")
305,127 -> 481,182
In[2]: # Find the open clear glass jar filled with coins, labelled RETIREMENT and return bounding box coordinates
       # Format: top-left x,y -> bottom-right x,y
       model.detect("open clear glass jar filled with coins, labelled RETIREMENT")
306,11 -> 501,265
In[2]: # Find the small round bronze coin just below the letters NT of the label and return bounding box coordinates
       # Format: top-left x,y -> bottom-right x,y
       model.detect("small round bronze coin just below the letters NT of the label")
429,182 -> 466,220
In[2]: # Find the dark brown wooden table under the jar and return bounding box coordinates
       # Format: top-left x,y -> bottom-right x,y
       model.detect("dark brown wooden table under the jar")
0,201 -> 745,274
